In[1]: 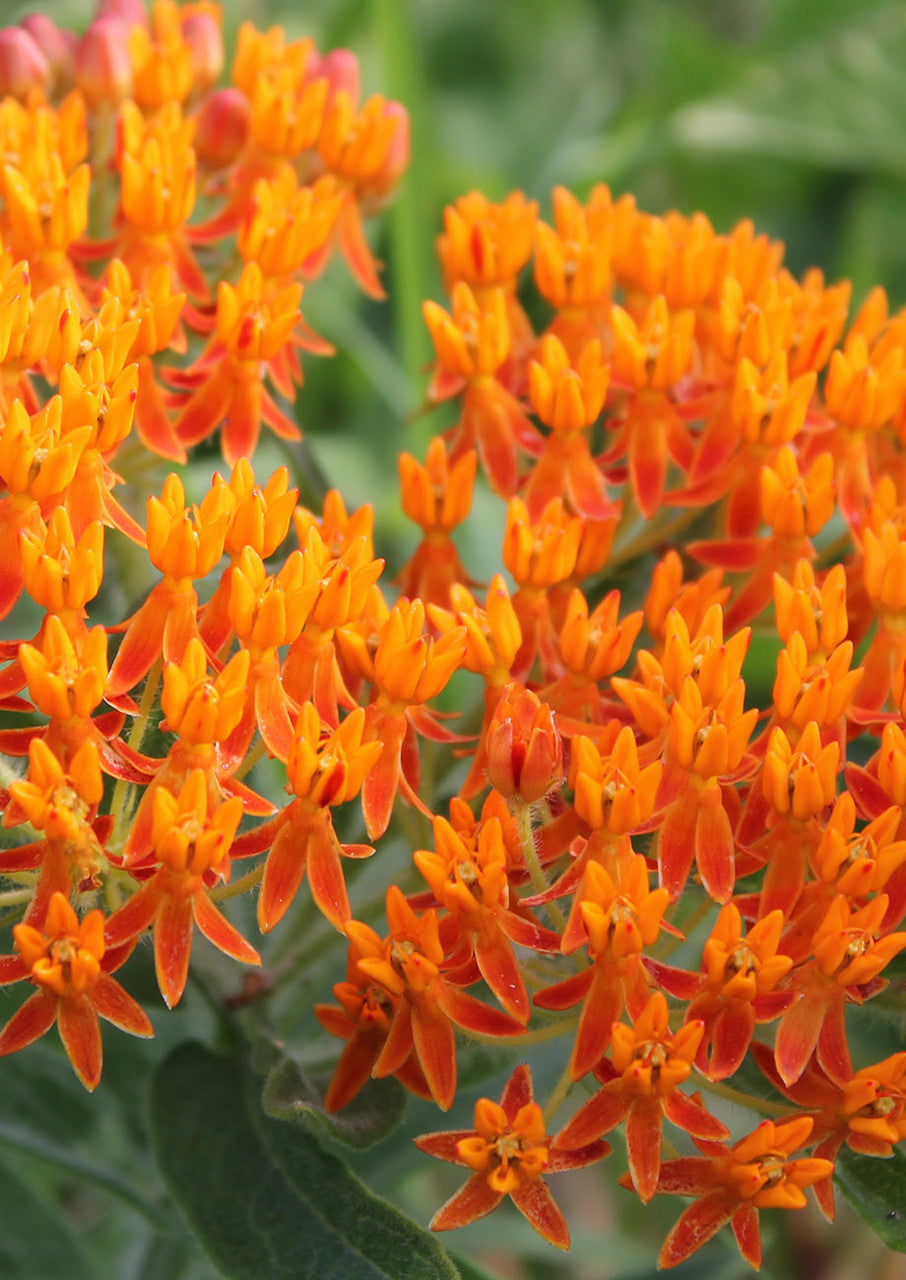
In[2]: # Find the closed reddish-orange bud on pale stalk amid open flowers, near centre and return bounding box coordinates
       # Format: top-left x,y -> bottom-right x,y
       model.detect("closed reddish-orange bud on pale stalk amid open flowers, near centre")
485,684 -> 563,804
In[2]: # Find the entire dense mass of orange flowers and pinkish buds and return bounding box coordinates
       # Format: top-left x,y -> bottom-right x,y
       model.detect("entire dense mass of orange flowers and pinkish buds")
0,0 -> 906,1266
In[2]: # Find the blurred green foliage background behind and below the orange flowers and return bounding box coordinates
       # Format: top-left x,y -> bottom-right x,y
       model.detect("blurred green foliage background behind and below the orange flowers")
0,0 -> 906,1280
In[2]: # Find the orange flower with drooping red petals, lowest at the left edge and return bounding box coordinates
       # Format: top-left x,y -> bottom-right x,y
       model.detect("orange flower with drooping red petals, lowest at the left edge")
0,893 -> 154,1089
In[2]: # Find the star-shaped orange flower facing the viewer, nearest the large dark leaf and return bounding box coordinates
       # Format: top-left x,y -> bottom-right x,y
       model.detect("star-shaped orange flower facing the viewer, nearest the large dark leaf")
415,1064 -> 610,1249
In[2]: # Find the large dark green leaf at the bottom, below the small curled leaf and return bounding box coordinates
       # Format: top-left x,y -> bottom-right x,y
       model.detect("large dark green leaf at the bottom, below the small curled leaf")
151,1043 -> 459,1280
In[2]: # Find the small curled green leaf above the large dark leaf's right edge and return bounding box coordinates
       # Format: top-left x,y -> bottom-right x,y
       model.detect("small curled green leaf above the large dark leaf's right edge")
262,1057 -> 406,1148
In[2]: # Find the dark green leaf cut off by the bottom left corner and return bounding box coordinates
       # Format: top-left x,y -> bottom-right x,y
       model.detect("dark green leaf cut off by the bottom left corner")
0,1164 -> 88,1280
